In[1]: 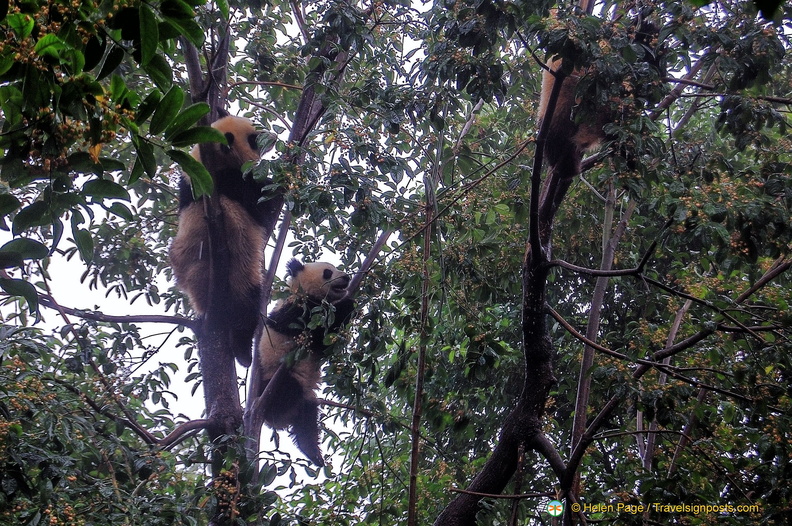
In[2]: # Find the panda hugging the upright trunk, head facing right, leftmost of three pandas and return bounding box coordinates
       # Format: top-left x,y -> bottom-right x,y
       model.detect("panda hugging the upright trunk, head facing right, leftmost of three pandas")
170,116 -> 265,367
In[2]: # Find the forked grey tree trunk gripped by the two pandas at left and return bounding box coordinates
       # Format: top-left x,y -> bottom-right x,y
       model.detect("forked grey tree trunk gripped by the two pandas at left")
182,10 -> 347,526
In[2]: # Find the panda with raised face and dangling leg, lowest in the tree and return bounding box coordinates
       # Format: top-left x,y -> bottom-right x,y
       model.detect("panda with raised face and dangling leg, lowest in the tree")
258,259 -> 354,466
